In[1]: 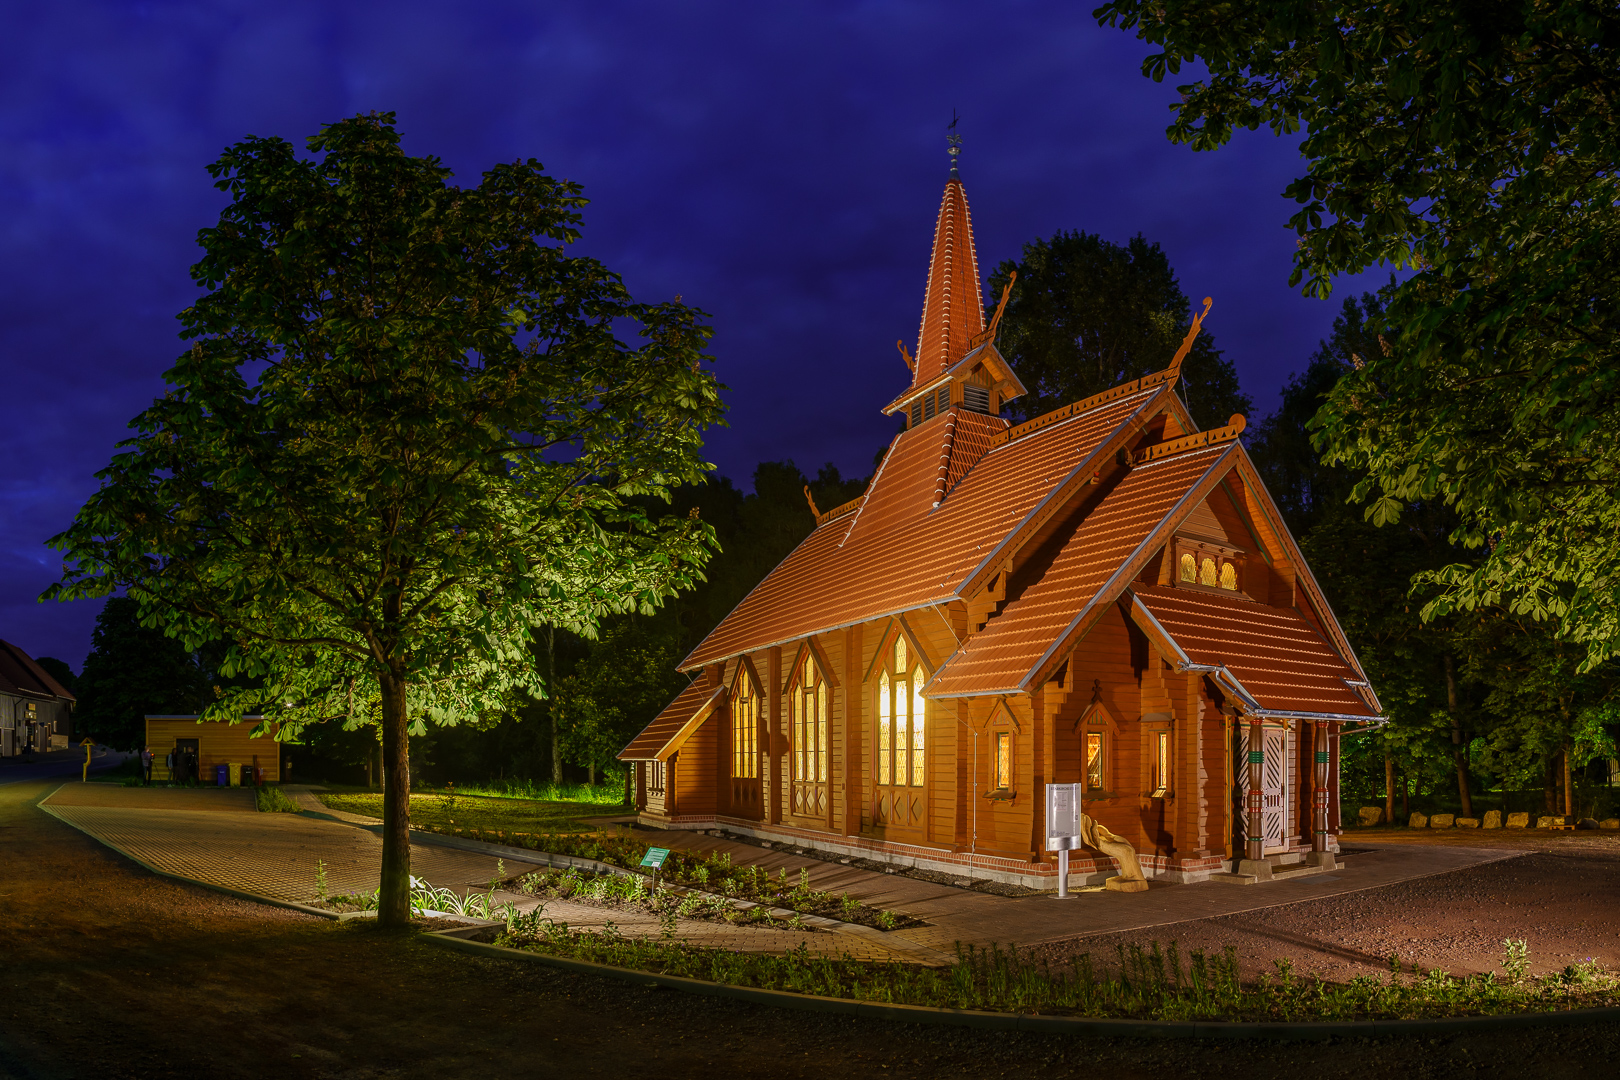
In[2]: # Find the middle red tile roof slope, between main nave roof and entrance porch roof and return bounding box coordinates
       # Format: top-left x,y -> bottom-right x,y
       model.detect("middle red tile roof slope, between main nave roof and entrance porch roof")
925,442 -> 1233,698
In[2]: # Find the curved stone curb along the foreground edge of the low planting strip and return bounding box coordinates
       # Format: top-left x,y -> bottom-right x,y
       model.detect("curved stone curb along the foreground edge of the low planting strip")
424,929 -> 1620,1041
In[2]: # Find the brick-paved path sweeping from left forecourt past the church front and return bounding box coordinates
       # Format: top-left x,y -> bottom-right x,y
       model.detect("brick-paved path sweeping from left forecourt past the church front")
42,784 -> 1521,960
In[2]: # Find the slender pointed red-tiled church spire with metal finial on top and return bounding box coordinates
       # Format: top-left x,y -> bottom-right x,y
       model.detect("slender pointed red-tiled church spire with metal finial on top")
912,118 -> 985,387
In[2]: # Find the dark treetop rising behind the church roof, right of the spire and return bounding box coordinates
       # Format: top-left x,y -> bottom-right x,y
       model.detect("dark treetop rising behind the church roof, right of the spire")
990,232 -> 1251,427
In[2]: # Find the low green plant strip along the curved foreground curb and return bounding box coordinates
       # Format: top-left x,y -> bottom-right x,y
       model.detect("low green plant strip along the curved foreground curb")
496,912 -> 1620,1022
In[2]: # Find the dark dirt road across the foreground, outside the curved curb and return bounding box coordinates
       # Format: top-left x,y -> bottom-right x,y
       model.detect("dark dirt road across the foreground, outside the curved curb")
9,784 -> 1620,1080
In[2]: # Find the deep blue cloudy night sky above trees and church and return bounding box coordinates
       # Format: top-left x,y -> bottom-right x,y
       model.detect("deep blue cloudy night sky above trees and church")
0,0 -> 1377,669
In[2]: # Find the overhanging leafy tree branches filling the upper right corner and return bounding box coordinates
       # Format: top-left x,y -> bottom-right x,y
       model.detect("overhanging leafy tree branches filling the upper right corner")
1095,0 -> 1620,664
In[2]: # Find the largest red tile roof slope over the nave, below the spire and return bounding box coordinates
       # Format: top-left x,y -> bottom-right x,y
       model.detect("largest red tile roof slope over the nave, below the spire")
680,390 -> 1162,670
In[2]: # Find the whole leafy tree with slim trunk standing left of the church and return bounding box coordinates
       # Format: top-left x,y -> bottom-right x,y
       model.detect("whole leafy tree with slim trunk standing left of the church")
47,113 -> 721,923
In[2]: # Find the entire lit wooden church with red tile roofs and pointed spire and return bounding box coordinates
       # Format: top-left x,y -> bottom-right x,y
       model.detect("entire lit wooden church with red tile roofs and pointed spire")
619,158 -> 1382,887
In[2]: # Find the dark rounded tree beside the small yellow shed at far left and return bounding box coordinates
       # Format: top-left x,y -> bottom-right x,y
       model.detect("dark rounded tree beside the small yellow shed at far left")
75,596 -> 207,755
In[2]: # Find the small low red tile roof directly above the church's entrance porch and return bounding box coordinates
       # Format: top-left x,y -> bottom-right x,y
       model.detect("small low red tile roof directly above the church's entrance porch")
1131,585 -> 1375,719
